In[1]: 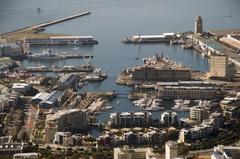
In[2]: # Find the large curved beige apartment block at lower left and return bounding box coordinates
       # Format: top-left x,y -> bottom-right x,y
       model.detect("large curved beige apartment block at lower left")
45,109 -> 88,143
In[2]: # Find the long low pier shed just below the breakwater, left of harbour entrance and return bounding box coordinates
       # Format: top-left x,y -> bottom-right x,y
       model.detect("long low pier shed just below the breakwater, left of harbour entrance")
23,36 -> 98,45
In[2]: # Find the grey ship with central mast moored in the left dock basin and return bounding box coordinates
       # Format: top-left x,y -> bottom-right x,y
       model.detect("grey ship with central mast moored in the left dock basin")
28,49 -> 66,60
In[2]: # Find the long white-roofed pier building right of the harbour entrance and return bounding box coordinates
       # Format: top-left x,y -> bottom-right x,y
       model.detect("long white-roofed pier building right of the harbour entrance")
122,33 -> 175,43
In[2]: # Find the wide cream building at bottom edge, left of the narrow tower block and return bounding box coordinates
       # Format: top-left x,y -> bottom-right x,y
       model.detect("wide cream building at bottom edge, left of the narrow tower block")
114,146 -> 160,159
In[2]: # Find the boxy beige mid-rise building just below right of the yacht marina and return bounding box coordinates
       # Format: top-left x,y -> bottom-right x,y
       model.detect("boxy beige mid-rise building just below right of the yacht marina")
190,106 -> 209,123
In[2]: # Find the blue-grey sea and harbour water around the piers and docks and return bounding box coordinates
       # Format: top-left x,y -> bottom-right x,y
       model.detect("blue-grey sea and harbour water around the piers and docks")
0,0 -> 240,122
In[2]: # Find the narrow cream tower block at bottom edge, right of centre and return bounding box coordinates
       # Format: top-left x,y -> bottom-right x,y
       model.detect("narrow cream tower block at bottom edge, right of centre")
165,141 -> 178,159
